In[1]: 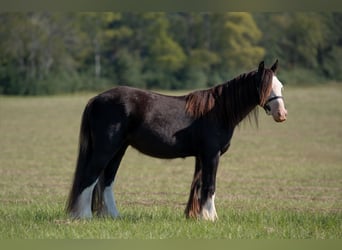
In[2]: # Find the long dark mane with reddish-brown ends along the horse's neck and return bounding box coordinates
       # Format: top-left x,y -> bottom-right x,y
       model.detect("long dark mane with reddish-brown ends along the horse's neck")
185,69 -> 273,126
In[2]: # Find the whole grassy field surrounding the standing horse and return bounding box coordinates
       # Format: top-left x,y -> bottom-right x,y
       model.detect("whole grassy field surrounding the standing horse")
0,85 -> 342,239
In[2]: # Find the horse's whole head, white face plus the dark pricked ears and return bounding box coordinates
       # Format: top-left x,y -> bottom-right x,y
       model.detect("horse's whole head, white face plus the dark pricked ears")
258,60 -> 287,122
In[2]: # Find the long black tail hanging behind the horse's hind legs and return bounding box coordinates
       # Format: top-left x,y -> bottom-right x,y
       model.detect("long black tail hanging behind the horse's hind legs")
66,101 -> 92,213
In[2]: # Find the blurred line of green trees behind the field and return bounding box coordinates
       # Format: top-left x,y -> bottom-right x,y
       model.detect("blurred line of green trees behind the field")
0,12 -> 342,95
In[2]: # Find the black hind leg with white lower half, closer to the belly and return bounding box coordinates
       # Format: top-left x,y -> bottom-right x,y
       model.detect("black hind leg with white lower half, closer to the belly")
101,145 -> 127,218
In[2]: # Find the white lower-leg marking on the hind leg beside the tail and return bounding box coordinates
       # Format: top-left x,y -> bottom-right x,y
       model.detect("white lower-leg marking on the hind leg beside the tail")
71,179 -> 98,219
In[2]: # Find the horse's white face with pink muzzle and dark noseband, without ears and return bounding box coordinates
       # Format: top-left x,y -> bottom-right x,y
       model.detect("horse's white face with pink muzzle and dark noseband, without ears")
264,75 -> 287,122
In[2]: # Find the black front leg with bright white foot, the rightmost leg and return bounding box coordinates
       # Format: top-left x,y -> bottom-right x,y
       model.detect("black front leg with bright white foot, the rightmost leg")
200,153 -> 220,221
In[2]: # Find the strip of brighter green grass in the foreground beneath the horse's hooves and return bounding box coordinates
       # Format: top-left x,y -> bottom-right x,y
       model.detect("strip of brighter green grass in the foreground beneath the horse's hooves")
0,204 -> 342,239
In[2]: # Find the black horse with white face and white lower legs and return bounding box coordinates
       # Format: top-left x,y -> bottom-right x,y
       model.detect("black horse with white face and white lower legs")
66,60 -> 287,221
